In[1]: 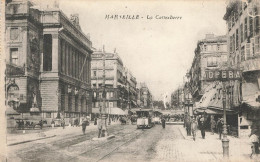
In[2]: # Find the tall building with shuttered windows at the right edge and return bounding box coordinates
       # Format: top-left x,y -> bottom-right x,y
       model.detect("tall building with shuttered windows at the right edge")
224,0 -> 260,137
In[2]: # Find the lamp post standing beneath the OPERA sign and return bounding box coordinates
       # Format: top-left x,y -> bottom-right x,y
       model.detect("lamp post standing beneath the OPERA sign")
222,82 -> 229,158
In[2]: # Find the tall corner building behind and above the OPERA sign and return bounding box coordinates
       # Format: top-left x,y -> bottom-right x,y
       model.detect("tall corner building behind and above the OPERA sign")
189,34 -> 228,102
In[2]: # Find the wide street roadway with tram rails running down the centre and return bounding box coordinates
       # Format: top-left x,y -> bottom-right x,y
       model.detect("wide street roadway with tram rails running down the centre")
8,124 -> 183,162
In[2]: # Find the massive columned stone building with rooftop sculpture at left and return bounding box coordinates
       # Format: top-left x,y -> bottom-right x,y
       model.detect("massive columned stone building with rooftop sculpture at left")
6,0 -> 93,123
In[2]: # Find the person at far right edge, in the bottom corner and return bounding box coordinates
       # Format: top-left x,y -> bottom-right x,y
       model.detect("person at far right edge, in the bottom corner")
249,122 -> 260,157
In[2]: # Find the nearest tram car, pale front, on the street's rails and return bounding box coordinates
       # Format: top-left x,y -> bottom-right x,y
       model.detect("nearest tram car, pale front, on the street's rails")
136,110 -> 153,128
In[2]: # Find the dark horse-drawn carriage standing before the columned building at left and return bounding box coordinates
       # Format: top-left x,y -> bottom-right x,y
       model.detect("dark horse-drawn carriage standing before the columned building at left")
15,119 -> 47,129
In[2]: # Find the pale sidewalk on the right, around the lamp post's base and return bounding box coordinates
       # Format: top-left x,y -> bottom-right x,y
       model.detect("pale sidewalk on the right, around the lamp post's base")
178,126 -> 260,162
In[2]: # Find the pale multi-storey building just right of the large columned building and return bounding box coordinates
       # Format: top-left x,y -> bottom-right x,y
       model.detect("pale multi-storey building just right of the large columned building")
91,51 -> 128,113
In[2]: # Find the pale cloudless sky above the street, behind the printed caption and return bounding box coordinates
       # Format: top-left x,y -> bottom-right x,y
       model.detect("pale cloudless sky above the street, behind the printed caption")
35,0 -> 226,100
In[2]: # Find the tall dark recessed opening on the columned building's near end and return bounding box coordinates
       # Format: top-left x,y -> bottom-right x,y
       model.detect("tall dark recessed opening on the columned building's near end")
43,34 -> 52,71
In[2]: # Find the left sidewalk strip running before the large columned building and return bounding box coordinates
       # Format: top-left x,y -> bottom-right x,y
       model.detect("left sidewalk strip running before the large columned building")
7,122 -> 119,146
